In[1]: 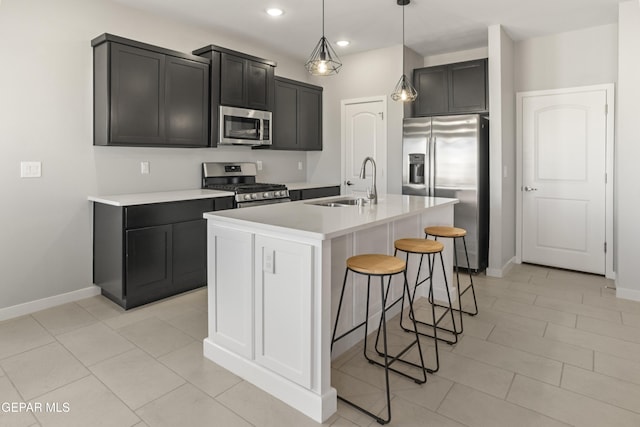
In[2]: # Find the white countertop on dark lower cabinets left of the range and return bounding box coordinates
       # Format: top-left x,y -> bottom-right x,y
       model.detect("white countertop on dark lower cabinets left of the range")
88,189 -> 235,206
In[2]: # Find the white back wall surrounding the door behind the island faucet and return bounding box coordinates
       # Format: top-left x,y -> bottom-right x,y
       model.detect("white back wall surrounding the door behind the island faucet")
307,45 -> 409,193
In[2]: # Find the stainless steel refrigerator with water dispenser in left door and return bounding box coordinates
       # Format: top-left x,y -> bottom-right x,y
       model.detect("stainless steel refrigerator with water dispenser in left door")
402,114 -> 489,271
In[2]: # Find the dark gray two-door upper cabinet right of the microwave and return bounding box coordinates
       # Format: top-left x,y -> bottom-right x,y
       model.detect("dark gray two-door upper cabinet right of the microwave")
271,77 -> 322,151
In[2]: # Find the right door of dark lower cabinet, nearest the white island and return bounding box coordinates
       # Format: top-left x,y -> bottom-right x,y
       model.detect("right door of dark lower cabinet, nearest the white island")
172,219 -> 207,293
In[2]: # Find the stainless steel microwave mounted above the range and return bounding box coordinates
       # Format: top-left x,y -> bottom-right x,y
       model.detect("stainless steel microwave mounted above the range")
218,105 -> 273,145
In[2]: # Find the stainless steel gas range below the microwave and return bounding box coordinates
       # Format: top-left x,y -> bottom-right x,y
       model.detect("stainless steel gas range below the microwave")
202,162 -> 291,208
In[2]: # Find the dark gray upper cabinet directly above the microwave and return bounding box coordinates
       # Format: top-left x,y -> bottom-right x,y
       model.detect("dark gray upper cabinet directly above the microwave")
192,45 -> 277,147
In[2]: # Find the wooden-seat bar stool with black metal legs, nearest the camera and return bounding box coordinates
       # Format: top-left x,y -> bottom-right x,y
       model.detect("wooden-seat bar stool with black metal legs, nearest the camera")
331,254 -> 427,424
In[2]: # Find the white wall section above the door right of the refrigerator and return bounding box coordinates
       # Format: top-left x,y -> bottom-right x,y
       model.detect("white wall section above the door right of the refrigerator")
515,24 -> 618,92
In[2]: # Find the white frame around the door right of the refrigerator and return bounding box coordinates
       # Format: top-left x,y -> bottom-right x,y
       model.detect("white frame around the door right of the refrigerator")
516,83 -> 615,279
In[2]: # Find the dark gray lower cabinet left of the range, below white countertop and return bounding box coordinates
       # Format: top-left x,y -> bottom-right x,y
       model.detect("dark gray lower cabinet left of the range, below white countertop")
93,197 -> 233,309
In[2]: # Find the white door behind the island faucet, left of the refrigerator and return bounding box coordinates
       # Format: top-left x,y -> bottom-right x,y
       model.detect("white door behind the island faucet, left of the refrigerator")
342,97 -> 387,196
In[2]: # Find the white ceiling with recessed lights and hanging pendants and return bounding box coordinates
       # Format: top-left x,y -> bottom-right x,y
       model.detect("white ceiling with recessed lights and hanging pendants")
114,0 -> 625,59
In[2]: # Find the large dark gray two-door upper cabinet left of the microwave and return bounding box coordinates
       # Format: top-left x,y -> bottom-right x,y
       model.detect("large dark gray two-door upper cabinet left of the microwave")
91,34 -> 209,147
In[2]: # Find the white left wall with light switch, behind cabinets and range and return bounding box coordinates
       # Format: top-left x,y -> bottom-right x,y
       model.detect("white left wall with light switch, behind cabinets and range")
0,0 -> 307,309
